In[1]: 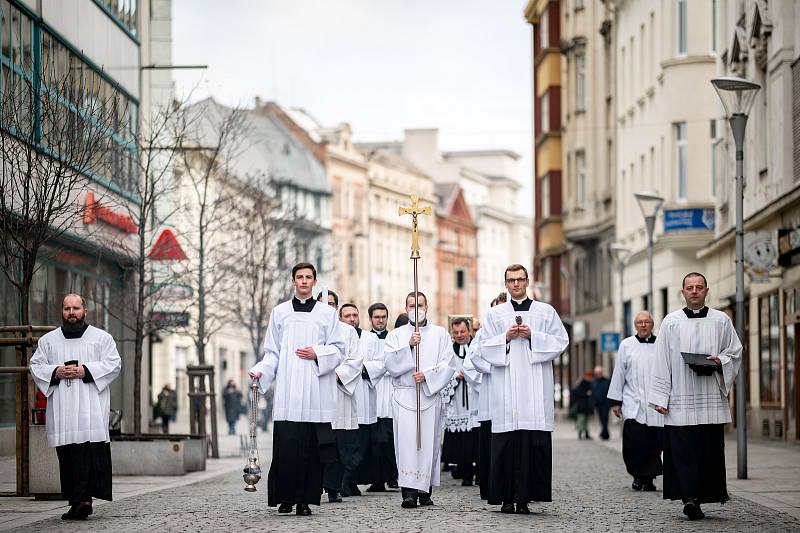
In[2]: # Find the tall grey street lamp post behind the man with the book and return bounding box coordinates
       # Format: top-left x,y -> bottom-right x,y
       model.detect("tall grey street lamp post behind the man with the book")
711,77 -> 761,479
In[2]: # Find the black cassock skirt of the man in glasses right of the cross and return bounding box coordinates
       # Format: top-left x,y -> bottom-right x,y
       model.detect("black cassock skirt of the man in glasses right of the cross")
488,430 -> 553,505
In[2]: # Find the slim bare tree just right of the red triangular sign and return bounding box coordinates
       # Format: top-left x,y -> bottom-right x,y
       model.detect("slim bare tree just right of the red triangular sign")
180,100 -> 248,364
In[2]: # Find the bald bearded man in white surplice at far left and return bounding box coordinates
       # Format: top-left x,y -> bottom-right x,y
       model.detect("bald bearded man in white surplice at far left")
30,294 -> 122,520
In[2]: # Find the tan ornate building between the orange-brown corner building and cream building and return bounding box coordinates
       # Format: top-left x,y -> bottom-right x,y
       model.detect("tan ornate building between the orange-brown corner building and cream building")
560,2 -> 619,383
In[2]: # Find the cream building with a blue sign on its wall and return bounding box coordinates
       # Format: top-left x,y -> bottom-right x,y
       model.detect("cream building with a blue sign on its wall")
613,0 -> 717,334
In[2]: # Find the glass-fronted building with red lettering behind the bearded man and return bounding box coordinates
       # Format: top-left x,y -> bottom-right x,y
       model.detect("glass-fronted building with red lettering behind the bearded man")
0,0 -> 151,436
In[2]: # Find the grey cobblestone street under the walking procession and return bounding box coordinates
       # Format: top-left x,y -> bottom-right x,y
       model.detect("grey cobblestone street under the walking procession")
12,434 -> 800,533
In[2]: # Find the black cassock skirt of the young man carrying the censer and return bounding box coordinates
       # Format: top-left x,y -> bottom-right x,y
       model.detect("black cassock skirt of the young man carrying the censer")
267,420 -> 337,507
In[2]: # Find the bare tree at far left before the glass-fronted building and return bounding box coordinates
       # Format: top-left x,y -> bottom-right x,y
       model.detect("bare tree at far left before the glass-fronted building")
0,56 -> 123,324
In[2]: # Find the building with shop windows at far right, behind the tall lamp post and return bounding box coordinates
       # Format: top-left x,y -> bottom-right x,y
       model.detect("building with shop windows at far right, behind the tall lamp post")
698,0 -> 800,440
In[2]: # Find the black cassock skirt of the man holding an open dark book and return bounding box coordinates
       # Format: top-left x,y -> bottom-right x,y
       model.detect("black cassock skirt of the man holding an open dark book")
664,424 -> 729,503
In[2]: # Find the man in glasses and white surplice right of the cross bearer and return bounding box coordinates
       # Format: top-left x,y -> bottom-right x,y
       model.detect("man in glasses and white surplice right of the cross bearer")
481,264 -> 569,514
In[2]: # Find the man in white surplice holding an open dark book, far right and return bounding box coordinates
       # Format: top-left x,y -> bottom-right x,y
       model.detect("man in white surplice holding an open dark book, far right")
647,272 -> 742,520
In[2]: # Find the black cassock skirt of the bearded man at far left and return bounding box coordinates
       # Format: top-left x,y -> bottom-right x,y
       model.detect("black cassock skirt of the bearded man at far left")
56,442 -> 111,505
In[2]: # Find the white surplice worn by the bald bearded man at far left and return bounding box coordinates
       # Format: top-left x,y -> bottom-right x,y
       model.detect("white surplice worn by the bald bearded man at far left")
30,326 -> 122,447
